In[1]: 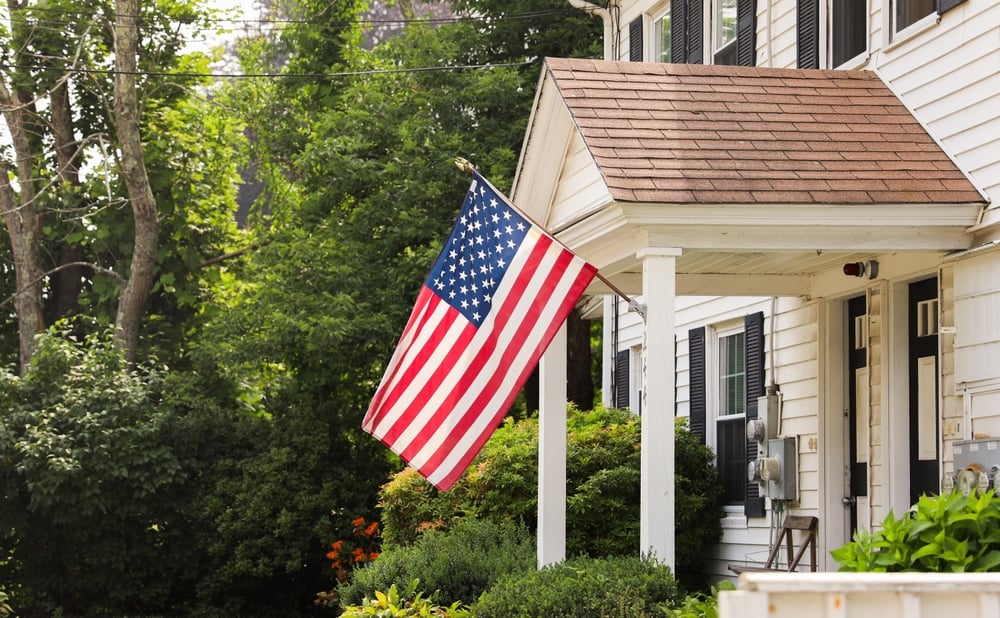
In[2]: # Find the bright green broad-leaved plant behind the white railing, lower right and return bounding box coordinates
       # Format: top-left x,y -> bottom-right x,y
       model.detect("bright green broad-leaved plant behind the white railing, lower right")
832,491 -> 1000,573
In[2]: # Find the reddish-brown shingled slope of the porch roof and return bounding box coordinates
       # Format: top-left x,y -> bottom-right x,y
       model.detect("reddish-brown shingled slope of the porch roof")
546,58 -> 983,204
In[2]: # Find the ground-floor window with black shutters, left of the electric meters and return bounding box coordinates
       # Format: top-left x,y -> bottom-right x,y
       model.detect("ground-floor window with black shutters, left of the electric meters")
688,313 -> 764,516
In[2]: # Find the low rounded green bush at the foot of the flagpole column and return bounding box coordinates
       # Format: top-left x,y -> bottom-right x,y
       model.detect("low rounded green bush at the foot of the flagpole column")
473,556 -> 677,618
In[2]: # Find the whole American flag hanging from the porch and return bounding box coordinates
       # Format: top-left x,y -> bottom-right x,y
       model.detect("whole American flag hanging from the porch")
362,172 -> 597,490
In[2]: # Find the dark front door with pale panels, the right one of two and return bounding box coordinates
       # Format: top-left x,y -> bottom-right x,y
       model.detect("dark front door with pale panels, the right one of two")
907,277 -> 940,504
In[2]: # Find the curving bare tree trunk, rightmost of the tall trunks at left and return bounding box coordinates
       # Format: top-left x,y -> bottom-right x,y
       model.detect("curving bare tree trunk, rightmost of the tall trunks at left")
114,0 -> 158,364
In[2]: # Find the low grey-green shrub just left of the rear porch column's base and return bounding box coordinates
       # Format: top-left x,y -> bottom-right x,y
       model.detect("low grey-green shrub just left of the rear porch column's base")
338,519 -> 535,607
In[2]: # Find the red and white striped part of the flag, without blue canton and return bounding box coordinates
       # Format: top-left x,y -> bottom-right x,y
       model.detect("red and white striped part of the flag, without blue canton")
363,171 -> 596,489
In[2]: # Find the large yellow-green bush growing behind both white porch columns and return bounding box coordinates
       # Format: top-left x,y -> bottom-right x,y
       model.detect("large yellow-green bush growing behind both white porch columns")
380,407 -> 722,590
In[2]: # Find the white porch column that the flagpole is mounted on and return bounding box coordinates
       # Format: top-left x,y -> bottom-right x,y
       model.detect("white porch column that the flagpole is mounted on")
637,247 -> 681,569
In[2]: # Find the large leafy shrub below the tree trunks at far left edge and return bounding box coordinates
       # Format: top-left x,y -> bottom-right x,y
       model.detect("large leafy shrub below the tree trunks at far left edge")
0,333 -> 185,613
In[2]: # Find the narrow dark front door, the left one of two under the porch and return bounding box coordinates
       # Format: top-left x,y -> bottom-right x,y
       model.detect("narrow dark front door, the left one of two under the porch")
844,296 -> 870,532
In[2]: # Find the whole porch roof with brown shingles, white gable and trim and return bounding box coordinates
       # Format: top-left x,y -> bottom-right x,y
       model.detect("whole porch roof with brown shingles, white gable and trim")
512,58 -> 985,295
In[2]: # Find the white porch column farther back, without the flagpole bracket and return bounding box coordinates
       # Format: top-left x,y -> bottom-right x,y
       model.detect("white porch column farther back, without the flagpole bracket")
537,322 -> 566,568
